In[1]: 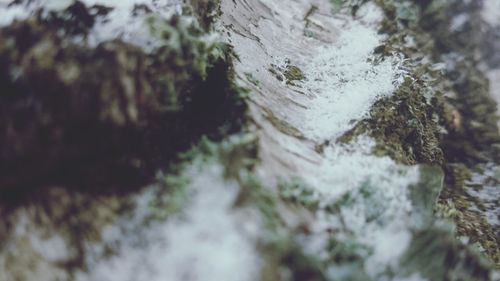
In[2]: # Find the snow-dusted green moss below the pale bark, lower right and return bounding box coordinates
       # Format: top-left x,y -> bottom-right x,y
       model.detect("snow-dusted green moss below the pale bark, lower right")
280,156 -> 452,281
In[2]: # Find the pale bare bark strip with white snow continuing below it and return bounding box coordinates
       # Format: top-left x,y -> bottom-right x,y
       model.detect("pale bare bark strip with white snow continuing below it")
222,0 -> 446,280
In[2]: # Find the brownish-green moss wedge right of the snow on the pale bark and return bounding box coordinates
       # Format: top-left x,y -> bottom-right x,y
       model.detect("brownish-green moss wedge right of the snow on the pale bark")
338,69 -> 443,164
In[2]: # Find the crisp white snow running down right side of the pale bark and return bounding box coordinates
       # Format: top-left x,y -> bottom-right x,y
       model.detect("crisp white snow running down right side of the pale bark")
276,5 -> 420,277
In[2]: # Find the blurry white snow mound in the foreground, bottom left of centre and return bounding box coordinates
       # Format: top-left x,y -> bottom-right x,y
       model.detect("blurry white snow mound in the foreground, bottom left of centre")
77,162 -> 260,281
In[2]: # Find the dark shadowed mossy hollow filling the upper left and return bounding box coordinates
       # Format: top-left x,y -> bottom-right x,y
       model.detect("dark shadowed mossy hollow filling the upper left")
0,2 -> 244,189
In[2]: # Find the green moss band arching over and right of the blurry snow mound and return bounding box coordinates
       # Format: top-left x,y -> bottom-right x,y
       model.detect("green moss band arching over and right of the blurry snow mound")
182,133 -> 327,281
